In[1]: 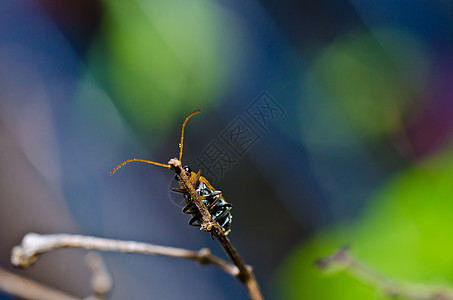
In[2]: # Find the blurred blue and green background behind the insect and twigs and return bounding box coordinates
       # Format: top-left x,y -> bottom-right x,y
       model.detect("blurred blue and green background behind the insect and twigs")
0,0 -> 453,299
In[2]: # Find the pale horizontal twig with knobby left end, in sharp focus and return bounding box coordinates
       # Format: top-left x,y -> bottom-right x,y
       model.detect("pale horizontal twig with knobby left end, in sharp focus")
11,233 -> 239,276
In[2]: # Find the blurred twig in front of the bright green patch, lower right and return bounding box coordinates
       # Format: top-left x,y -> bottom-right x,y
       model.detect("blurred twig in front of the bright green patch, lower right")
316,247 -> 453,300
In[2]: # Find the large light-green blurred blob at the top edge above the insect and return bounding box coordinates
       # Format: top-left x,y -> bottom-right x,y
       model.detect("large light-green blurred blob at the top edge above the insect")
90,0 -> 244,136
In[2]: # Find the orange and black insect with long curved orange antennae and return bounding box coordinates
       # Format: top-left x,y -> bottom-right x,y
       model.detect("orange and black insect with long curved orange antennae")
111,110 -> 233,235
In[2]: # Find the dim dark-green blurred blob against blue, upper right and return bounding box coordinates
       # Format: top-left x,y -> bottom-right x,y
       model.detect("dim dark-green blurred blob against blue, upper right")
313,29 -> 426,138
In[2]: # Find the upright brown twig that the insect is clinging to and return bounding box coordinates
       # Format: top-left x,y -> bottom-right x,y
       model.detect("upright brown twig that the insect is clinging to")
168,158 -> 264,300
